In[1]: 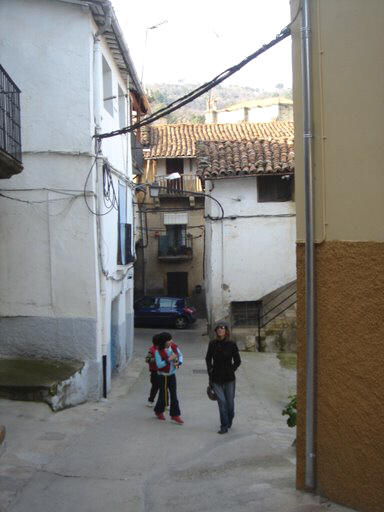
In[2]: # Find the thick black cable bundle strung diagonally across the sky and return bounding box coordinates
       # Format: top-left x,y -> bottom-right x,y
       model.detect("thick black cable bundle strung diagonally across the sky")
95,6 -> 301,140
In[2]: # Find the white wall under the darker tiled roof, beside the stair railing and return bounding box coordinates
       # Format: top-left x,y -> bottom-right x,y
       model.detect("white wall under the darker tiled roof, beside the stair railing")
205,177 -> 296,323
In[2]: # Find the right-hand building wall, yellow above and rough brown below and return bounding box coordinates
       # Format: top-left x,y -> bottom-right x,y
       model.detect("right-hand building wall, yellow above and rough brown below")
292,0 -> 384,512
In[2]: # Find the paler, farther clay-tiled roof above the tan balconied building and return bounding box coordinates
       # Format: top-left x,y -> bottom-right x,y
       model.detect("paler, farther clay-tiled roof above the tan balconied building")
143,121 -> 293,158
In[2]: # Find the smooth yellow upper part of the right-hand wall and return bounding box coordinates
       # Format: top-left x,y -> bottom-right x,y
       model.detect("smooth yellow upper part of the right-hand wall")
292,0 -> 384,241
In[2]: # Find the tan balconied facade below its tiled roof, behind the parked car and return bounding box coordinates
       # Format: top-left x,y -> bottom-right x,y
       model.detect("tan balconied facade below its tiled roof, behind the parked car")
135,152 -> 205,316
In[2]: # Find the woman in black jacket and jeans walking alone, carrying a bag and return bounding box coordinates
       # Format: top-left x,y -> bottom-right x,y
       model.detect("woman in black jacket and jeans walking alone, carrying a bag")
205,323 -> 241,434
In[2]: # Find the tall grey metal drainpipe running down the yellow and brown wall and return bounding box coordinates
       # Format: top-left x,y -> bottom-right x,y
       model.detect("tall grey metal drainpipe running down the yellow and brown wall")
300,0 -> 315,489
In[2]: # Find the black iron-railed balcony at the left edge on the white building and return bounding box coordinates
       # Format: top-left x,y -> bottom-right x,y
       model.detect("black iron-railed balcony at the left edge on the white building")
0,65 -> 23,178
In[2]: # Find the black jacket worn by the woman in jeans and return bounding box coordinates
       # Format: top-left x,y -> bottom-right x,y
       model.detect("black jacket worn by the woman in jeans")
205,340 -> 241,383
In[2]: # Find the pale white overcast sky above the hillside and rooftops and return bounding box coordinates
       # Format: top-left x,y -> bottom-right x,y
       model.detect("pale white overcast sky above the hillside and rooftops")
112,0 -> 292,89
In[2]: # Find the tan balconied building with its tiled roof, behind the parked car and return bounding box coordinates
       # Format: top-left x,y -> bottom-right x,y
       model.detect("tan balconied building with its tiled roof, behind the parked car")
135,121 -> 293,316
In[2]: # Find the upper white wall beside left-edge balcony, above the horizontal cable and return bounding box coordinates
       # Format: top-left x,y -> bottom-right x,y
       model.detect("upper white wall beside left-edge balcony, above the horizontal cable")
0,0 -> 91,152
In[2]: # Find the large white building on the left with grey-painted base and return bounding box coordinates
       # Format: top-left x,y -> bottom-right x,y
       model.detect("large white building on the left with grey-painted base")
0,0 -> 145,405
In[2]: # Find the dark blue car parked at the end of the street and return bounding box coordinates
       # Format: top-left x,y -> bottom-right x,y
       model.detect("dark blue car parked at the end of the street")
134,297 -> 196,329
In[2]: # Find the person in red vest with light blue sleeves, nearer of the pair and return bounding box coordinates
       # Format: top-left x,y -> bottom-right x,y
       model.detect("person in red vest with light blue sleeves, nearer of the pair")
155,332 -> 184,425
